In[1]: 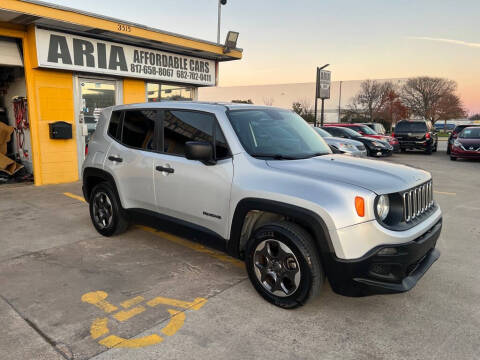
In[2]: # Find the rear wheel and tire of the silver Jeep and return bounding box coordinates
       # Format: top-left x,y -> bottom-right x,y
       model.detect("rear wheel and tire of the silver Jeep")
89,182 -> 128,236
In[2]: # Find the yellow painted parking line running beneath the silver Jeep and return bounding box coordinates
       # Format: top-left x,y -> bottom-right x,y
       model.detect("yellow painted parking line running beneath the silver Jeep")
63,192 -> 245,268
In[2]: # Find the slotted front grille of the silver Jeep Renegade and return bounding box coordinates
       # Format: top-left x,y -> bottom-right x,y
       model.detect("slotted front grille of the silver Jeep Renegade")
403,180 -> 433,222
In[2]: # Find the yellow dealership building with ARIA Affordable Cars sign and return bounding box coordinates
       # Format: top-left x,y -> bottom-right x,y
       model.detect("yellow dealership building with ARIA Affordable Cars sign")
0,0 -> 242,185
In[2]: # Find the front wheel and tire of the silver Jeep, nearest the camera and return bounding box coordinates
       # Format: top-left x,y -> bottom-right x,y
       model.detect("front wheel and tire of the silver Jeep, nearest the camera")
245,221 -> 325,309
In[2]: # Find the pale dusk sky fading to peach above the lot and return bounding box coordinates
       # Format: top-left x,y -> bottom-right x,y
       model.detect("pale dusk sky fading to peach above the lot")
49,0 -> 480,113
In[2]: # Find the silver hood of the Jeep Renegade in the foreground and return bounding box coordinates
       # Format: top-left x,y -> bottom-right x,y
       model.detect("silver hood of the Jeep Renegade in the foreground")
267,155 -> 431,194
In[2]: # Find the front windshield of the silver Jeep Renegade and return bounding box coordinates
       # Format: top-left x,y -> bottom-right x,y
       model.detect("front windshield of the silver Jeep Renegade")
228,109 -> 331,160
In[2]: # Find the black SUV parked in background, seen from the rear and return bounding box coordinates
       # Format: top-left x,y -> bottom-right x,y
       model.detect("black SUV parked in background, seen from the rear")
392,120 -> 438,154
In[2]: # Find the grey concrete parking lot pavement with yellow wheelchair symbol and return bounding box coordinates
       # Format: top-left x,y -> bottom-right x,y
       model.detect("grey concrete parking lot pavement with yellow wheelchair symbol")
0,143 -> 480,360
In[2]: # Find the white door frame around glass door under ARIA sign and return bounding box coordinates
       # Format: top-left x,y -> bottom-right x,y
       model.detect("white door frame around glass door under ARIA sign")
73,74 -> 123,178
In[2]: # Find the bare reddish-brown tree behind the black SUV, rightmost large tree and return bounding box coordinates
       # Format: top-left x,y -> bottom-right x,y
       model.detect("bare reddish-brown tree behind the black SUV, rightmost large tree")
401,76 -> 463,123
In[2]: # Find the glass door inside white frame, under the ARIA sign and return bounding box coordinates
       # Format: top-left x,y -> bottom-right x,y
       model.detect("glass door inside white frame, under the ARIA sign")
75,77 -> 122,171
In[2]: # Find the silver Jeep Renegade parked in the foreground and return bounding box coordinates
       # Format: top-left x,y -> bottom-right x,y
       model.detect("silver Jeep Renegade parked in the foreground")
82,102 -> 442,308
